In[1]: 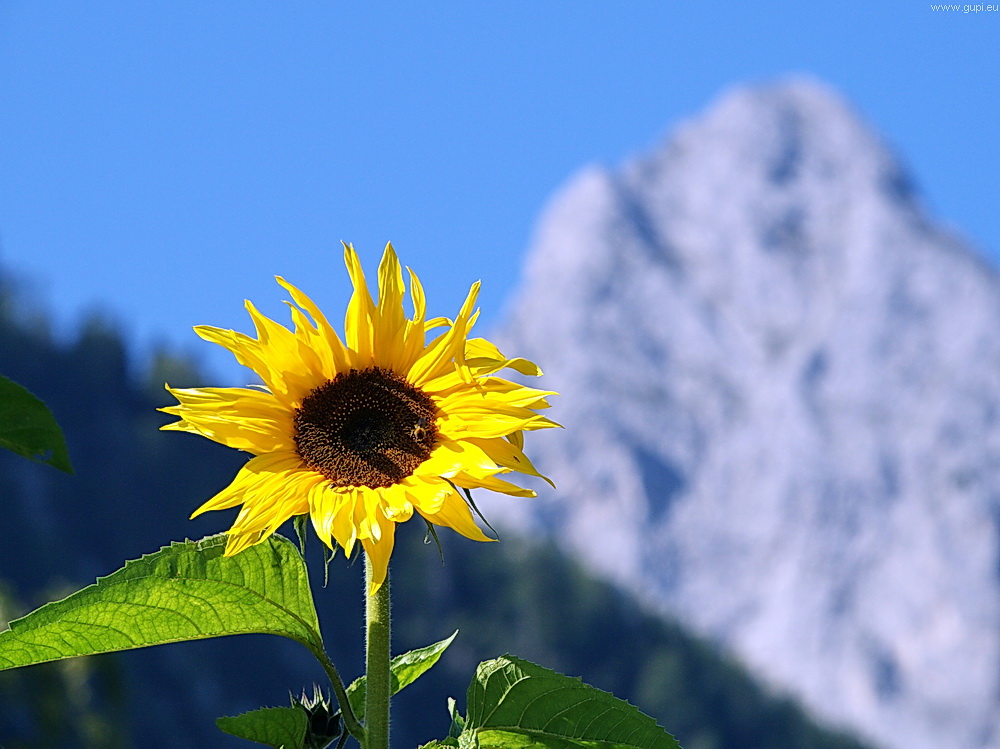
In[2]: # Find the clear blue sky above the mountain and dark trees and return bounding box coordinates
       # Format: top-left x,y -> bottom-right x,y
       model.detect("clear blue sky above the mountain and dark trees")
0,0 -> 1000,384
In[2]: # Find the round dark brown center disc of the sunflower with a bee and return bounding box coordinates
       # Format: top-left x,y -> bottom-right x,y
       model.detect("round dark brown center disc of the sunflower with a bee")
295,367 -> 437,489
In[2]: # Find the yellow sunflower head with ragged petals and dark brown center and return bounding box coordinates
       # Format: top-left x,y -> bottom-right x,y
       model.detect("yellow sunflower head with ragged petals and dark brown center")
161,244 -> 557,593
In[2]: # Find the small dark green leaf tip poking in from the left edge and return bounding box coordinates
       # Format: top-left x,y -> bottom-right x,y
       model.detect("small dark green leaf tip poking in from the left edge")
0,375 -> 73,473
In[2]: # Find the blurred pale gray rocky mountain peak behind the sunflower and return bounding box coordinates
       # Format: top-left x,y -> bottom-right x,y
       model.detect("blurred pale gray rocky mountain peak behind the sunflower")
483,79 -> 1000,749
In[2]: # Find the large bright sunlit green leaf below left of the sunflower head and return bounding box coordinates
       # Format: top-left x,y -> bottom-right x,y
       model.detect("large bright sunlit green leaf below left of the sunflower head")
0,534 -> 323,670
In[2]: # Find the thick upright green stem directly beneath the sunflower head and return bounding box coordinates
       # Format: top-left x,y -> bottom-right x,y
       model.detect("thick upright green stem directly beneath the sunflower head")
364,554 -> 392,749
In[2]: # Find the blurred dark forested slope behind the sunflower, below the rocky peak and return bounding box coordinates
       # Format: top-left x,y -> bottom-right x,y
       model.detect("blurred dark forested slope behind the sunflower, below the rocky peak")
0,276 -> 862,749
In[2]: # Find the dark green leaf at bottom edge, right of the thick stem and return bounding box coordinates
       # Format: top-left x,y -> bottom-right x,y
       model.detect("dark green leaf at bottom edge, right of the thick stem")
458,655 -> 679,749
